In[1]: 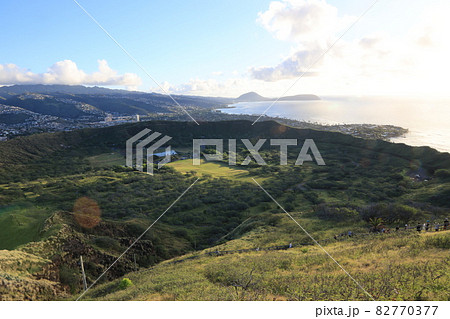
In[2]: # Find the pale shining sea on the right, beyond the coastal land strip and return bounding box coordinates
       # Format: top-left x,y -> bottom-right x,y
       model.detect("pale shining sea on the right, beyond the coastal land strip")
221,97 -> 450,152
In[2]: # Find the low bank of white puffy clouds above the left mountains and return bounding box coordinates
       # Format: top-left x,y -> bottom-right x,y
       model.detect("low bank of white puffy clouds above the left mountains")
0,60 -> 141,88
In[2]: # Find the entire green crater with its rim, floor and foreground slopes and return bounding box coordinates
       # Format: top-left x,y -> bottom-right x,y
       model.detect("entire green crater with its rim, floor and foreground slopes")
0,121 -> 450,300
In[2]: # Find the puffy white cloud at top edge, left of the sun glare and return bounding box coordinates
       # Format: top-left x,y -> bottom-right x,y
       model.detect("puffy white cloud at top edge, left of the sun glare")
250,0 -> 354,82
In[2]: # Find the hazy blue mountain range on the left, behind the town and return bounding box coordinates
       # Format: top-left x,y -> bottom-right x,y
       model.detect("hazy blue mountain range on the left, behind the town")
0,85 -> 232,119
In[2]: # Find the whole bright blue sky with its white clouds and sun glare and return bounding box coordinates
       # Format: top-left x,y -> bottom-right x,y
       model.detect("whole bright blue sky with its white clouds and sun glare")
0,0 -> 450,97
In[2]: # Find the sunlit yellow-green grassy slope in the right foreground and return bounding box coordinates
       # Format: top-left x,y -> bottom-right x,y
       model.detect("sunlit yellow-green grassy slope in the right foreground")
86,230 -> 450,300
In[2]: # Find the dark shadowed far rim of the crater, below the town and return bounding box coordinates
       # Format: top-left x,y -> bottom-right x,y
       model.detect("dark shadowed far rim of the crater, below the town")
0,121 -> 450,170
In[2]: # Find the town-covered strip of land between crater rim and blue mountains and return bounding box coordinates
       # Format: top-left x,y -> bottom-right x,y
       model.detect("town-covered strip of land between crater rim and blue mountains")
0,104 -> 408,141
